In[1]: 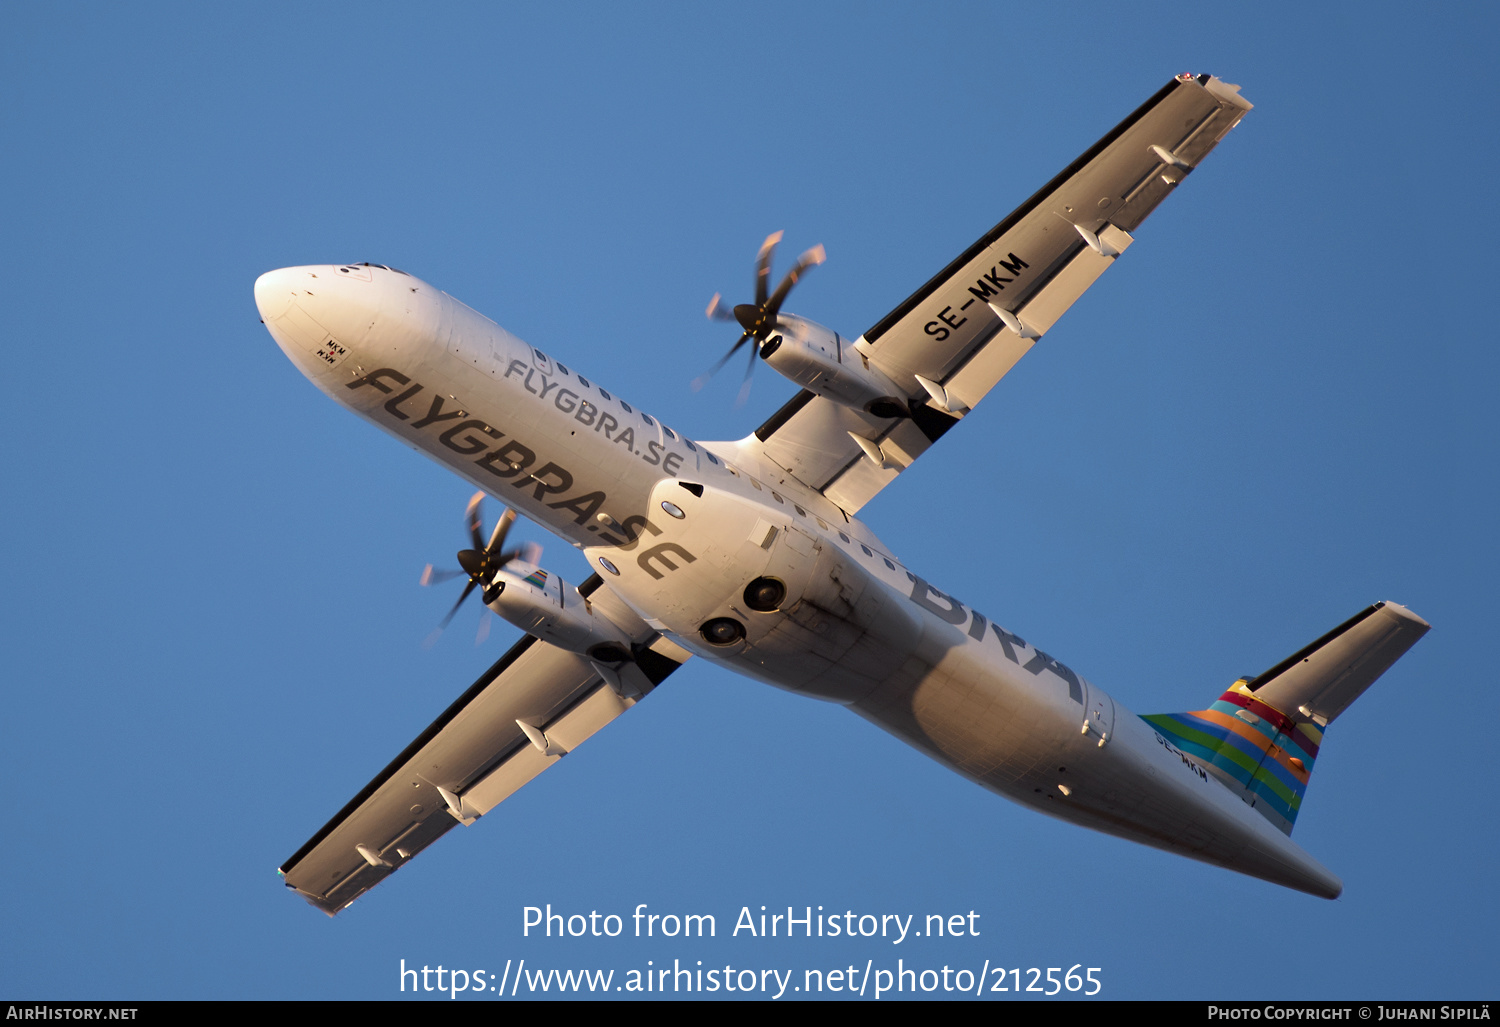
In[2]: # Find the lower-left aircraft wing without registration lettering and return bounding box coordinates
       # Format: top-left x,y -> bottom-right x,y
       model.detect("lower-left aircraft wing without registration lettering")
279,574 -> 689,916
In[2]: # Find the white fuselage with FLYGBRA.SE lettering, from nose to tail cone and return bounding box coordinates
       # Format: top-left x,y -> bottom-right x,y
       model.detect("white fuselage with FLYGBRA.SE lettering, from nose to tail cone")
255,265 -> 1341,897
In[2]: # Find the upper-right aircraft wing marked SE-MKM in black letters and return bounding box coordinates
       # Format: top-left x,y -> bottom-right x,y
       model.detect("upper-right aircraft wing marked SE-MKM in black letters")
734,75 -> 1251,514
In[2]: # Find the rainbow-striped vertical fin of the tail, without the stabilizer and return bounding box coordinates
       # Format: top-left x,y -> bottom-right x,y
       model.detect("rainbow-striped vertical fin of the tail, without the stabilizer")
1142,678 -> 1323,835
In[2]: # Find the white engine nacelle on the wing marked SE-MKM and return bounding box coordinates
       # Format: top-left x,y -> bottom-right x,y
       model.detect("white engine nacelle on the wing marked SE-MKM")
761,313 -> 911,417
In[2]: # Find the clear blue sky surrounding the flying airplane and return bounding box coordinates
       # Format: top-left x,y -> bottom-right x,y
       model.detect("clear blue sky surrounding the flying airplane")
0,4 -> 1500,999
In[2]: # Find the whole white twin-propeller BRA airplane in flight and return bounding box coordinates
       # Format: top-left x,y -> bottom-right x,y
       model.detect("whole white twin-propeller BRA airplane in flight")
255,75 -> 1430,916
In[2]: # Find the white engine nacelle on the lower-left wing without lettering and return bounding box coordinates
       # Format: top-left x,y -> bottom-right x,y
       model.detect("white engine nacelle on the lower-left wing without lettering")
485,561 -> 630,666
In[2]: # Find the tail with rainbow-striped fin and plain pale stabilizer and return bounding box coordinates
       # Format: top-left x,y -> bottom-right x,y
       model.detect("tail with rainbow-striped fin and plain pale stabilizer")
1142,603 -> 1431,835
